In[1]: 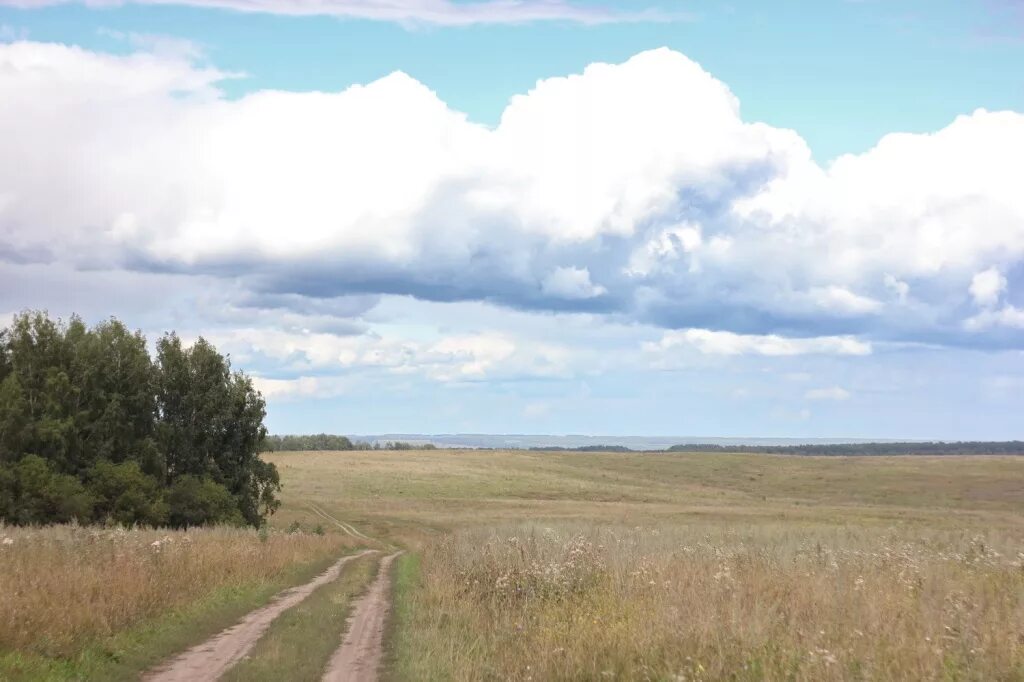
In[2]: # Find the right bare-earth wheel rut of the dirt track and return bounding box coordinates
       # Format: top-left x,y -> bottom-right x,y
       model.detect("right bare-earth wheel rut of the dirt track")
324,552 -> 400,682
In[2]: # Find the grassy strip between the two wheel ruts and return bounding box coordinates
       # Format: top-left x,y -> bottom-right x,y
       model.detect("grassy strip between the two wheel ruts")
221,554 -> 380,682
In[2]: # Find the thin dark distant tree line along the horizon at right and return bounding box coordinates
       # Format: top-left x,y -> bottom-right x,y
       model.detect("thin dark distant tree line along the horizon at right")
669,440 -> 1024,456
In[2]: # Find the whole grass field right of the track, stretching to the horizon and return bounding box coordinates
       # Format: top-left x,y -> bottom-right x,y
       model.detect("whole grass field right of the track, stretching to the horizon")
269,451 -> 1024,680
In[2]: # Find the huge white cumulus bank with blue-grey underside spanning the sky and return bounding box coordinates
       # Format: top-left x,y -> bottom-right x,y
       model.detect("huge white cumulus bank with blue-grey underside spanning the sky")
0,39 -> 1024,348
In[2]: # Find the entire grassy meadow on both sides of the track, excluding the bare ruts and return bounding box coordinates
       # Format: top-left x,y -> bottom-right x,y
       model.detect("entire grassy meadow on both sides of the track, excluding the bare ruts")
0,451 -> 1024,681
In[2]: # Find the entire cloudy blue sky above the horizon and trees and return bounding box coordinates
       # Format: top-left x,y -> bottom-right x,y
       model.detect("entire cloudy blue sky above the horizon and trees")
0,0 -> 1024,439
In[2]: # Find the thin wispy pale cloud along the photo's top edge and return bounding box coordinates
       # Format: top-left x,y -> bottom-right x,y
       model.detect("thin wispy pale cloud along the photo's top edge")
0,0 -> 671,26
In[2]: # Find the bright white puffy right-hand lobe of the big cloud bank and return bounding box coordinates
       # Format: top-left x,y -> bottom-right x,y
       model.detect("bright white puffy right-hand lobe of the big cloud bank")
737,110 -> 1024,283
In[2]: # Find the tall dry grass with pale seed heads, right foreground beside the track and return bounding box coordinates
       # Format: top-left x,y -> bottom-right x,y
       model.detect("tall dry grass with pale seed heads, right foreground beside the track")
394,524 -> 1024,681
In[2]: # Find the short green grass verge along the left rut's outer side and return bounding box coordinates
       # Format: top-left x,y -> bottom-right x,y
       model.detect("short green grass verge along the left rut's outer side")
0,556 -> 346,682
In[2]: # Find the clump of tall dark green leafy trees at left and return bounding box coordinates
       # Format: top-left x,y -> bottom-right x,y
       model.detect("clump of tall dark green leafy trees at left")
0,312 -> 281,527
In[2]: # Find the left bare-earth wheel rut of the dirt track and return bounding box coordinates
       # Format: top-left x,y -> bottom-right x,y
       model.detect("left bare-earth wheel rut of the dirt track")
142,550 -> 378,682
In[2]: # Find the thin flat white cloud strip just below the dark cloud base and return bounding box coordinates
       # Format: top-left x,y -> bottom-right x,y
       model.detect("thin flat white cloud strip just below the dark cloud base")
646,329 -> 871,356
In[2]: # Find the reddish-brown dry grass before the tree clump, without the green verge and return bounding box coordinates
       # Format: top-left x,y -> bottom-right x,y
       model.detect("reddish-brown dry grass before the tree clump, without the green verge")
0,525 -> 353,657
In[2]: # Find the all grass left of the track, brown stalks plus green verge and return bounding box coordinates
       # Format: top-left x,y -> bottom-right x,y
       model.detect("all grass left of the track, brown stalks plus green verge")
0,526 -> 357,680
